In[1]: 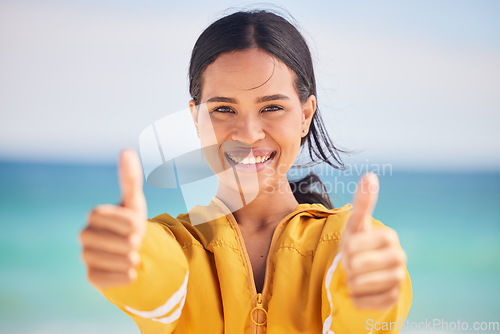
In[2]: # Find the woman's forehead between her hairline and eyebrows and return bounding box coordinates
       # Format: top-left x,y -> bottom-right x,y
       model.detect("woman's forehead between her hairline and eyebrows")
202,49 -> 296,100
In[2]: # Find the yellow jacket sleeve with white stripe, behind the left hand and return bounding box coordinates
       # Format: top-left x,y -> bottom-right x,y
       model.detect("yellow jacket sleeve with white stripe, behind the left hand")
100,221 -> 189,333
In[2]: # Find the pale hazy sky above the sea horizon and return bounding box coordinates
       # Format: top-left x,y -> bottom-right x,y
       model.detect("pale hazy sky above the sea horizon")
0,0 -> 500,170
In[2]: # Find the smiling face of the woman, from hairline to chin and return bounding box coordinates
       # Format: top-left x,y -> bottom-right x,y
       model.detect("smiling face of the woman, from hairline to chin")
190,49 -> 316,197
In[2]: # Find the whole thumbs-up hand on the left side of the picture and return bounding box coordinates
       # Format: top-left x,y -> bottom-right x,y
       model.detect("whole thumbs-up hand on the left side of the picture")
80,150 -> 147,288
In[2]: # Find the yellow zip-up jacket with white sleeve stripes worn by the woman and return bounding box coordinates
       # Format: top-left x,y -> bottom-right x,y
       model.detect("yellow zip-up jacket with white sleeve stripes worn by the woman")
101,197 -> 412,334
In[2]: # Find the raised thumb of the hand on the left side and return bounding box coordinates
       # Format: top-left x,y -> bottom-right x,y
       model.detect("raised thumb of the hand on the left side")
118,149 -> 147,215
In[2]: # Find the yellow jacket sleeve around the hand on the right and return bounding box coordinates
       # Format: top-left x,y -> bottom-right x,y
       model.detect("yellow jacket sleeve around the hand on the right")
322,219 -> 413,334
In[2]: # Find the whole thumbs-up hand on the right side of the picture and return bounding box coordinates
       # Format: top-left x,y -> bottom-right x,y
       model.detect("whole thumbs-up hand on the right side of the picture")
340,173 -> 406,310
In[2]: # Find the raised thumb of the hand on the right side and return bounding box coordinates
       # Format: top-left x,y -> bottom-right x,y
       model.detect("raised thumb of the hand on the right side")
346,172 -> 379,234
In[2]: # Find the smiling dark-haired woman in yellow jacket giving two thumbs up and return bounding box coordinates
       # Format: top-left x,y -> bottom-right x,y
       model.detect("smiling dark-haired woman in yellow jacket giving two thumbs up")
80,11 -> 412,333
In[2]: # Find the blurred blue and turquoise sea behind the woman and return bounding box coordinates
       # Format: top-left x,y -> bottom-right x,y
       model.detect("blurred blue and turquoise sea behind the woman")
0,161 -> 500,333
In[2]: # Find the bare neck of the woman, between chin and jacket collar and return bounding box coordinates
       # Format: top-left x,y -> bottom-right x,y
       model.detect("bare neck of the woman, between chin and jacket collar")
217,176 -> 299,233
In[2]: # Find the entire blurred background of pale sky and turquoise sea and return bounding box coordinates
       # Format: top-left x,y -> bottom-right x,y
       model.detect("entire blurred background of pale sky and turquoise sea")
0,0 -> 500,333
